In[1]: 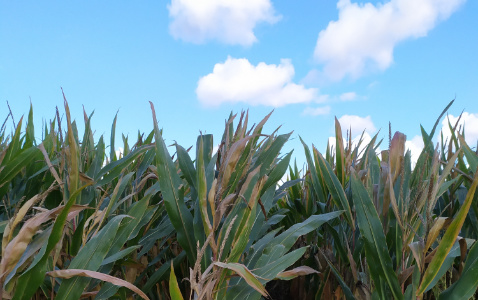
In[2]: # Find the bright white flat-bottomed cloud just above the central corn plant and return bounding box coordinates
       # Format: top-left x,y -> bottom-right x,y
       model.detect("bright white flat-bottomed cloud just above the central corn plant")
196,57 -> 319,107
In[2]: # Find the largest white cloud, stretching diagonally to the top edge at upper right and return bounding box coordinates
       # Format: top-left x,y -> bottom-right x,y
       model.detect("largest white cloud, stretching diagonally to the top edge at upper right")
314,0 -> 466,80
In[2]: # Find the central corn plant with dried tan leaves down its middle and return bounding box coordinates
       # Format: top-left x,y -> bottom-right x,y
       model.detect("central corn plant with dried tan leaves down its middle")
148,104 -> 341,299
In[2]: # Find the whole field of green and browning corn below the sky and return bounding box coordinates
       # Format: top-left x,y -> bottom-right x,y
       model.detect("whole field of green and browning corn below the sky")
0,98 -> 478,300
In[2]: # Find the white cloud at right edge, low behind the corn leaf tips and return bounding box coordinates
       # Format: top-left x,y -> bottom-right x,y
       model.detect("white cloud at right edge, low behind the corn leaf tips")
442,112 -> 478,148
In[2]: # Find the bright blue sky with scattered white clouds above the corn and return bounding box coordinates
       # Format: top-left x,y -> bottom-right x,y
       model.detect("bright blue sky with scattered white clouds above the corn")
0,0 -> 478,161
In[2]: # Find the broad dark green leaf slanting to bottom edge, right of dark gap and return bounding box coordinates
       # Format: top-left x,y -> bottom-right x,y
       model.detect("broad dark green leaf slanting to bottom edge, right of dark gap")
351,173 -> 403,299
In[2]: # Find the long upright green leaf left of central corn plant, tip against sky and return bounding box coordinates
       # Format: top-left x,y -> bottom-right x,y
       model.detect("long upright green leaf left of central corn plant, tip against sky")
150,102 -> 196,262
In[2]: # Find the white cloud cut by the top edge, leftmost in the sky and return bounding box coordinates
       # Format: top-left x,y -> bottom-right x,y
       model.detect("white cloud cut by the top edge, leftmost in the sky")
168,0 -> 280,46
